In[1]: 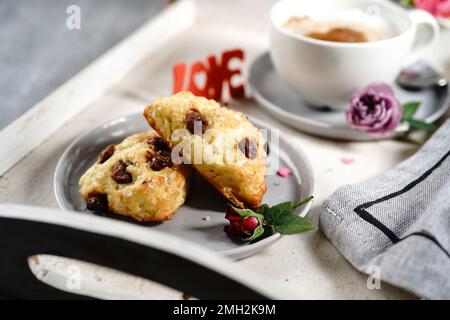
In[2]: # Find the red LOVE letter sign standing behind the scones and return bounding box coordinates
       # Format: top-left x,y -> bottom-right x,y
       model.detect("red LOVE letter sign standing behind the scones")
173,49 -> 245,101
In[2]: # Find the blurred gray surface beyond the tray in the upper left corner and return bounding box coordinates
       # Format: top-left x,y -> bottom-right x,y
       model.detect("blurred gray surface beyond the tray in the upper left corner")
0,0 -> 165,129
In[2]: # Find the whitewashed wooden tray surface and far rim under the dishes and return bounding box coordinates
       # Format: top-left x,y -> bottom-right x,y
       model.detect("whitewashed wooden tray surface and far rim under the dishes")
0,0 -> 442,299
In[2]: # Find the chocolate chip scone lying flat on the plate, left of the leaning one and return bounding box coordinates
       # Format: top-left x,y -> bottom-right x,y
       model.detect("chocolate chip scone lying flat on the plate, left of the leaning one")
79,131 -> 189,221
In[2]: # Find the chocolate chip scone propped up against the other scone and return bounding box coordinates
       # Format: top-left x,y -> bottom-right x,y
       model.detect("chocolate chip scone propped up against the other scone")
144,92 -> 266,208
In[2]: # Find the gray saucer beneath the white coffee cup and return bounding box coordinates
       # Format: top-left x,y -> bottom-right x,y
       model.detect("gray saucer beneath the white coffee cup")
248,52 -> 449,141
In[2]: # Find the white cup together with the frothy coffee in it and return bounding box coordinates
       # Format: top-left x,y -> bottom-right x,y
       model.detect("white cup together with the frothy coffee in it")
270,0 -> 439,109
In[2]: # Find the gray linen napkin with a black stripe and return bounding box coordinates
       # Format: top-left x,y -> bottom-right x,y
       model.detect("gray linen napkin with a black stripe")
319,119 -> 450,299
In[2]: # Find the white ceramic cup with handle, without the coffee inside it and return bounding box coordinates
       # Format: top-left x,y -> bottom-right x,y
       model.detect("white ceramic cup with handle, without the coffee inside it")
270,0 -> 439,109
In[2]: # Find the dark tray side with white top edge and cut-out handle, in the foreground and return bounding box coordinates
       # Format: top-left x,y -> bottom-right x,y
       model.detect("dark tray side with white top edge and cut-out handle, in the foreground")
0,205 -> 286,299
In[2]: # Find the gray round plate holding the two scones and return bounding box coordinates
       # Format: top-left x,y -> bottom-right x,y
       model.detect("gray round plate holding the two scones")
54,114 -> 313,259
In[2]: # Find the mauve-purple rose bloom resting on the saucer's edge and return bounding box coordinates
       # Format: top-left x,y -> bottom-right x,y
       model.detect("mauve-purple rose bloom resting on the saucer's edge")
345,83 -> 403,137
